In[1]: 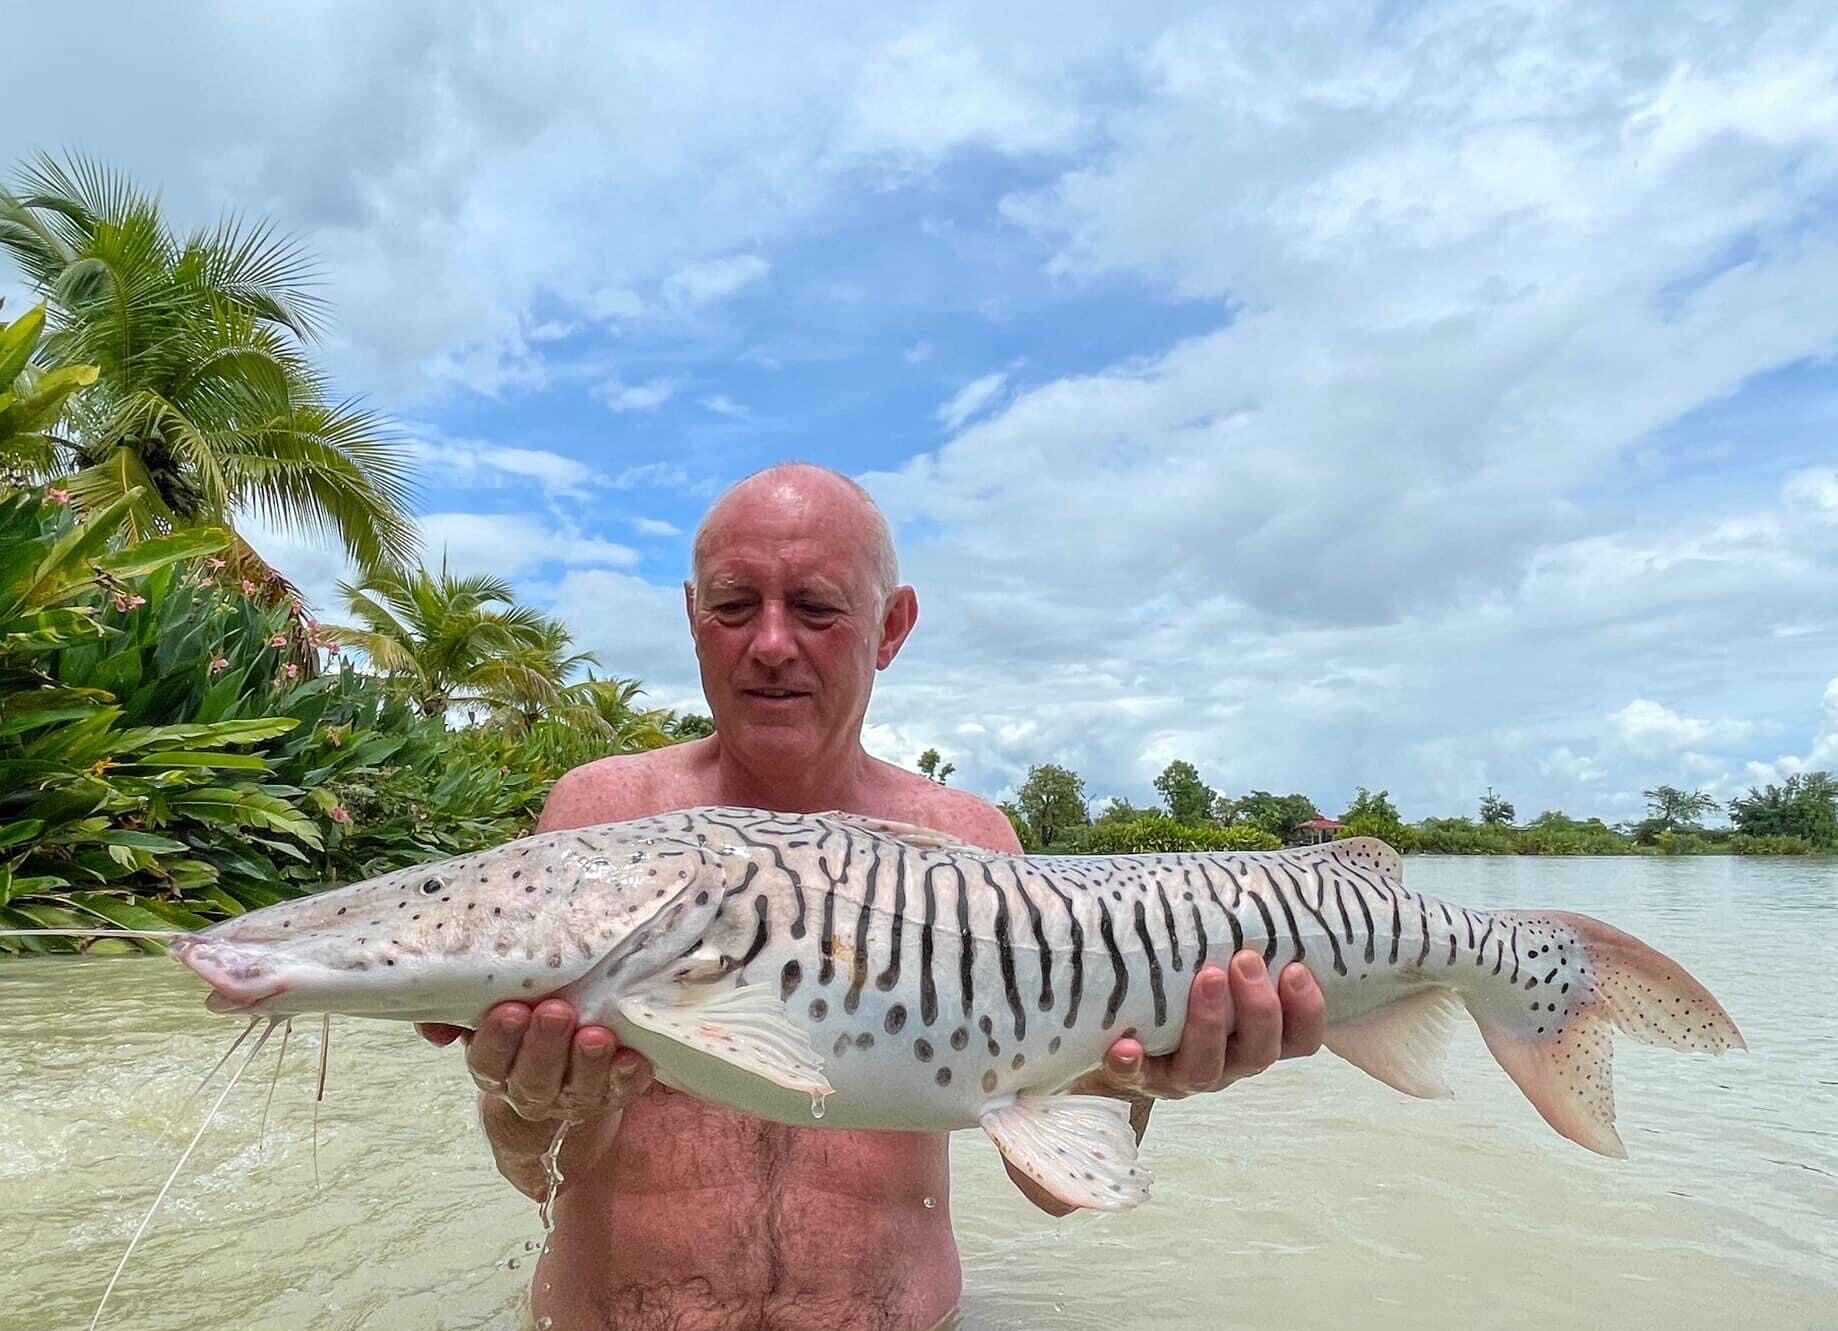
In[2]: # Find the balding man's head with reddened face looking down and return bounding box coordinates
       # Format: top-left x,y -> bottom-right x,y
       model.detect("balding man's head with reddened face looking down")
684,463 -> 917,770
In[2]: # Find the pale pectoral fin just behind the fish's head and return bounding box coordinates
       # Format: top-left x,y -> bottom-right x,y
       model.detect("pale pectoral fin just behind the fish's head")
619,982 -> 833,1098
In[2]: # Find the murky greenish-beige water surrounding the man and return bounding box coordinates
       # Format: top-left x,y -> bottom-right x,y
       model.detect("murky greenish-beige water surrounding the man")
0,857 -> 1838,1331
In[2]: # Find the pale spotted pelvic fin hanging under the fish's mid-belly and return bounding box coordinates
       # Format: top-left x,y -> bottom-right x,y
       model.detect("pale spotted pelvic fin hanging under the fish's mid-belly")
980,1094 -> 1154,1212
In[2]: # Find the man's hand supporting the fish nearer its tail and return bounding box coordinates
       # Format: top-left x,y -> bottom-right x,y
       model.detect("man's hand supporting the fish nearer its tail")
1073,949 -> 1327,1099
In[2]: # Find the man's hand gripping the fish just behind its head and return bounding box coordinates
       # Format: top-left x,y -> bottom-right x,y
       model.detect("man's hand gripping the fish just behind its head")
417,998 -> 651,1123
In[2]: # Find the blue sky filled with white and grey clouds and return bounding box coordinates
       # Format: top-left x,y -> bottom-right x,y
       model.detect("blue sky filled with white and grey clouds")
0,0 -> 1838,822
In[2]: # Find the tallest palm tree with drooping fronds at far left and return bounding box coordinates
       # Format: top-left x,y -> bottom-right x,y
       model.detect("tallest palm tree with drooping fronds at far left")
0,156 -> 415,574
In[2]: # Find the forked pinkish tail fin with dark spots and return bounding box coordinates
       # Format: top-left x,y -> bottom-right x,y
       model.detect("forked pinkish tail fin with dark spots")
1463,910 -> 1748,1156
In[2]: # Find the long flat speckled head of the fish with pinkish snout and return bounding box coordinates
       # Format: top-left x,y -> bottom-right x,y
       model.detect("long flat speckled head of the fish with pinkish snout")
171,824 -> 733,1026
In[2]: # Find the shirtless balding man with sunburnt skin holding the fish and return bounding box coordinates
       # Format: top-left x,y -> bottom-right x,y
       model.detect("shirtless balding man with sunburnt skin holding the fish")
425,463 -> 1323,1331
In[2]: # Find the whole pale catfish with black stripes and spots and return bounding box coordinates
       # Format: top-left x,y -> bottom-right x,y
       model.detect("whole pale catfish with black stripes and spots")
171,807 -> 1744,1210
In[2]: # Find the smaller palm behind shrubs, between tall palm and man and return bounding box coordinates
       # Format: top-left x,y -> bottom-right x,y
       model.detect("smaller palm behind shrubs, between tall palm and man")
320,563 -> 558,717
